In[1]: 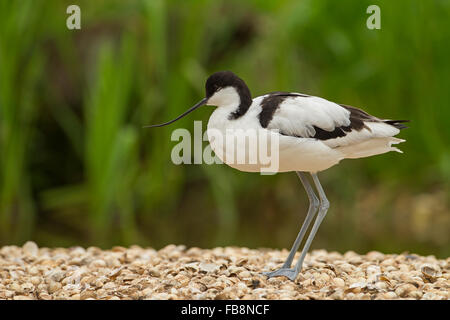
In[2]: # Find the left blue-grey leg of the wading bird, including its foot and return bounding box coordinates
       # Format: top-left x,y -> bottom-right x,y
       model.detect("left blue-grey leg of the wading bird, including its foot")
264,171 -> 319,278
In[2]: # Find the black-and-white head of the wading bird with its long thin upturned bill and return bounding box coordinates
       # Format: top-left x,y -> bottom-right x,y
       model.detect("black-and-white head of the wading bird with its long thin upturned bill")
144,71 -> 252,128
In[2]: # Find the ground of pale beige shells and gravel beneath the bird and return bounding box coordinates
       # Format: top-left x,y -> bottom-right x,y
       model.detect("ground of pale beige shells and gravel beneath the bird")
0,242 -> 450,300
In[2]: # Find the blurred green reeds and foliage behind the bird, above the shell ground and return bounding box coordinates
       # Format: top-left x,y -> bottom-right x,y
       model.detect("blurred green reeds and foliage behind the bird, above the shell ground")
0,0 -> 450,258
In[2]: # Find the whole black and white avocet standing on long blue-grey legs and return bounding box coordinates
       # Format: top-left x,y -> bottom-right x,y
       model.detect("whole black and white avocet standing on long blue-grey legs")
148,71 -> 408,280
